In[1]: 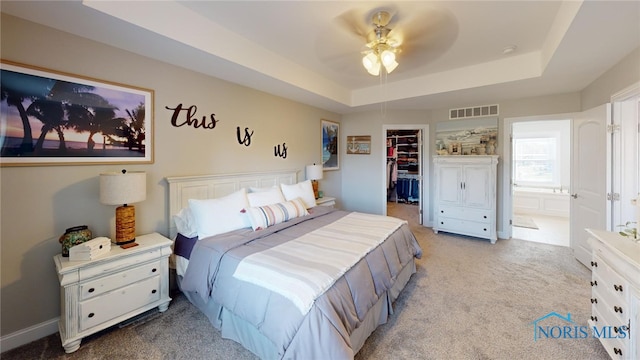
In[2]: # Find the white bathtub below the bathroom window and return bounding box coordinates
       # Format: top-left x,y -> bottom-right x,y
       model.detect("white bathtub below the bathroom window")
513,187 -> 569,218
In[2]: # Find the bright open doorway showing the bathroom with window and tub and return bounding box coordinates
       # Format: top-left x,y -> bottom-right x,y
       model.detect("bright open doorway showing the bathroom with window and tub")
511,119 -> 571,247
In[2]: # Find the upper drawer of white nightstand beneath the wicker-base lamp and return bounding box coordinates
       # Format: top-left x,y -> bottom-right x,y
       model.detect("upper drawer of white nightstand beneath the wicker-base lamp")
80,260 -> 161,301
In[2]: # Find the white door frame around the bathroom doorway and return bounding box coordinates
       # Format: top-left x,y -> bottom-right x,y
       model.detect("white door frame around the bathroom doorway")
498,113 -> 576,239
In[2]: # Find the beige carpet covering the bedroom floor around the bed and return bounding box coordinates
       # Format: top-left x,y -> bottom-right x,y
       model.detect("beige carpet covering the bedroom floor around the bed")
1,207 -> 608,360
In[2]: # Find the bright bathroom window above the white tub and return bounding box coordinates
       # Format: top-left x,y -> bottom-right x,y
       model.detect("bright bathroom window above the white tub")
513,138 -> 560,187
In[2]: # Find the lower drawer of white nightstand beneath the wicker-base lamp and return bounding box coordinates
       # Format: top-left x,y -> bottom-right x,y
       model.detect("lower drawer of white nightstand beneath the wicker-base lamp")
80,276 -> 160,331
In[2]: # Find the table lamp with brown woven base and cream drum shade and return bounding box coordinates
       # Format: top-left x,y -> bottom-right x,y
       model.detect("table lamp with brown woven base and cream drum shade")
100,170 -> 147,246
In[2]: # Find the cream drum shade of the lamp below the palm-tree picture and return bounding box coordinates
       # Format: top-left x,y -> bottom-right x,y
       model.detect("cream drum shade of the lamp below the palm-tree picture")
100,170 -> 147,205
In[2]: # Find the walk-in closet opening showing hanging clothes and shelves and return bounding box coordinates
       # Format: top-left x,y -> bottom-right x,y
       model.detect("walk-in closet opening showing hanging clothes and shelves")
385,127 -> 428,224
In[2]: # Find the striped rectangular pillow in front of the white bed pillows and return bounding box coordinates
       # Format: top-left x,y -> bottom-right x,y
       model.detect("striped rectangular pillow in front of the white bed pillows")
247,198 -> 309,231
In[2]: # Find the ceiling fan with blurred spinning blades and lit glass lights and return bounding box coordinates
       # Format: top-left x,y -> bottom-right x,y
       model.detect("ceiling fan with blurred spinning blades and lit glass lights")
317,2 -> 458,76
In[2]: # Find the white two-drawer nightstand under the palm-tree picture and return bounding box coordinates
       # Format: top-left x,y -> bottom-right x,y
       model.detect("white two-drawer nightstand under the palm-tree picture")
53,233 -> 171,353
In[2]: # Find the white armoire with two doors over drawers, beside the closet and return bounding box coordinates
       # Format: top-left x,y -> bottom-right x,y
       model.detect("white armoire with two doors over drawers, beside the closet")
433,155 -> 498,244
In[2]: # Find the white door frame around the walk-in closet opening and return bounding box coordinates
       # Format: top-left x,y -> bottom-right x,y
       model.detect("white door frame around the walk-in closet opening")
381,124 -> 431,226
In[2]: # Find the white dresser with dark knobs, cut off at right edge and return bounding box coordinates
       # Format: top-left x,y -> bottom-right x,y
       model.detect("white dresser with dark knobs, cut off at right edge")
587,229 -> 640,360
